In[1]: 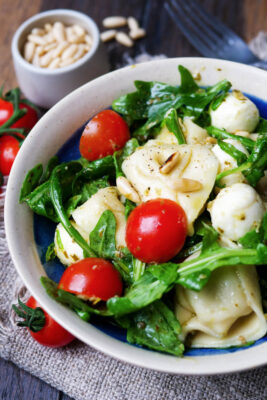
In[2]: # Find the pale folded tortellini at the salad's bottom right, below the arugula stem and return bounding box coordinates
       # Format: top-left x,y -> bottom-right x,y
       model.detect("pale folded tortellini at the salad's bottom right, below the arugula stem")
175,265 -> 267,347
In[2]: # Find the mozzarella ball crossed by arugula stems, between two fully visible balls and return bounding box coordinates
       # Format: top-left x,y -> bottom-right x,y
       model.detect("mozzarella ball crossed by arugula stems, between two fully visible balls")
212,139 -> 249,186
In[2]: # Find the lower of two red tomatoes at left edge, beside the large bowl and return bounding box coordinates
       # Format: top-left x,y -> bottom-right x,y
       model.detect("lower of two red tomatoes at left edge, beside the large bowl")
0,135 -> 19,175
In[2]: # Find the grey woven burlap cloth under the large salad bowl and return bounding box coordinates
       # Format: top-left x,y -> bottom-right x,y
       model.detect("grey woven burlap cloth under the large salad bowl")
0,33 -> 267,400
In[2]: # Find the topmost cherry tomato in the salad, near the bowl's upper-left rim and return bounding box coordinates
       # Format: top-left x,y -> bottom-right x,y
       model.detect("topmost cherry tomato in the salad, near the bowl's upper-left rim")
80,110 -> 130,161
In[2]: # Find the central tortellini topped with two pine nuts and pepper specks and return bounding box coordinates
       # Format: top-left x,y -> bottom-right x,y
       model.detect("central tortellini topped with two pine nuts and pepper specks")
122,140 -> 218,234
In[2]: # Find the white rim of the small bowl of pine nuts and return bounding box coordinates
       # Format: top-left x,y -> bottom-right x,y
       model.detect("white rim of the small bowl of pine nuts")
11,8 -> 100,76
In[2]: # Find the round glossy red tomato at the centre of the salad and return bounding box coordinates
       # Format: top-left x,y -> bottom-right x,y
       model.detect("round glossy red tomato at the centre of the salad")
126,199 -> 187,263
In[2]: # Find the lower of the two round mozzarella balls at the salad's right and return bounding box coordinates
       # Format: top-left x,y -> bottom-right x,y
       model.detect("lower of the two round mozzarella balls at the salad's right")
208,183 -> 264,241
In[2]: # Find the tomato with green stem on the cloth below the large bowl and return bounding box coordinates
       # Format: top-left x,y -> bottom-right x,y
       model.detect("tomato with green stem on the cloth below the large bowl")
13,296 -> 75,347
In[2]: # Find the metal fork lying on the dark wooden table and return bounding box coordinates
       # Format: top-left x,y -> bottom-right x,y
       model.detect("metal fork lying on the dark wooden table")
164,0 -> 267,69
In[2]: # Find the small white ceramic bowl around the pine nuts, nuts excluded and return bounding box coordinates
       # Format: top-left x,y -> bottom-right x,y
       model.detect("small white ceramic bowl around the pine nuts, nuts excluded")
11,9 -> 109,108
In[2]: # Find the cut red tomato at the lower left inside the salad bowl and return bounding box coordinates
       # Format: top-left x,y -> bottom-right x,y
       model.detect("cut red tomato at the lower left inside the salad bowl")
58,257 -> 122,301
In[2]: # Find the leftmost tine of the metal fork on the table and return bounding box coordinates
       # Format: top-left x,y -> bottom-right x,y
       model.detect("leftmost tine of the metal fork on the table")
165,0 -> 221,57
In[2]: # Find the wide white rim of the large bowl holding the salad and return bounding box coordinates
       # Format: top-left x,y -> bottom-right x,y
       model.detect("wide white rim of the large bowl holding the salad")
5,58 -> 267,375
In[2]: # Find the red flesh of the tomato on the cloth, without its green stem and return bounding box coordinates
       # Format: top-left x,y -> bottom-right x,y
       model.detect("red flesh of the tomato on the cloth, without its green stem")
27,296 -> 75,347
